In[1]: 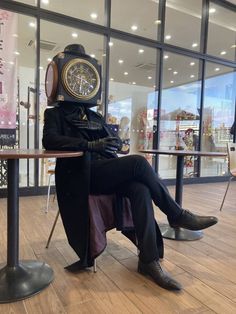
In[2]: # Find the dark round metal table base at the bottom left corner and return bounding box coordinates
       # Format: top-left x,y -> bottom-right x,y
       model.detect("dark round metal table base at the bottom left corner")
0,260 -> 54,303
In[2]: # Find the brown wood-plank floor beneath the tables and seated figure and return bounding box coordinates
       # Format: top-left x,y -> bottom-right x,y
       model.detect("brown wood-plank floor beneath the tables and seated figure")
0,182 -> 236,314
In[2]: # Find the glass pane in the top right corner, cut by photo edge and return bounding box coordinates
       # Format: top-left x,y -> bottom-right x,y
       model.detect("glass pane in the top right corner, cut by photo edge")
207,3 -> 236,61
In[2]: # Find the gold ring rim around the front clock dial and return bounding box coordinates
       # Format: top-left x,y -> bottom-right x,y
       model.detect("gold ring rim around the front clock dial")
62,58 -> 100,100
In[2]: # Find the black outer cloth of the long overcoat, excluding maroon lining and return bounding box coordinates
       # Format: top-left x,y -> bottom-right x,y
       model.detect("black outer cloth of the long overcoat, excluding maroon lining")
43,105 -> 163,267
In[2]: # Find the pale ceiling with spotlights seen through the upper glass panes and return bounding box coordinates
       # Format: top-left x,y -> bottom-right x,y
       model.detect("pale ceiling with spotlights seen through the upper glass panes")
6,0 -> 236,88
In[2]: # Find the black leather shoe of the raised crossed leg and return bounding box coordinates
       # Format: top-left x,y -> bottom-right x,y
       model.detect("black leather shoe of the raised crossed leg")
168,210 -> 218,230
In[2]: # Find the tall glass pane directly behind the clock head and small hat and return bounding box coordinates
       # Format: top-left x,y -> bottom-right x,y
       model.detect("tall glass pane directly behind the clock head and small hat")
39,20 -> 106,185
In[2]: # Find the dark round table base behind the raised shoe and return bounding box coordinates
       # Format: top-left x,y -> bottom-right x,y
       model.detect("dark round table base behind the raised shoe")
160,224 -> 203,241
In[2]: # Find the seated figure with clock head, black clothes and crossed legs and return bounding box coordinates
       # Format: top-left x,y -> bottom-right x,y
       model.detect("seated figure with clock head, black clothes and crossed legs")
43,44 -> 217,290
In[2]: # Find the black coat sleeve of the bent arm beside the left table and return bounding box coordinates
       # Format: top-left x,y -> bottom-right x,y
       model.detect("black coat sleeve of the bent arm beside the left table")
42,108 -> 88,151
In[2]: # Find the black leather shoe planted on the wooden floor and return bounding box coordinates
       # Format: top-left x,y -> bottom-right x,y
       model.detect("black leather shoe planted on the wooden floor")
138,260 -> 182,290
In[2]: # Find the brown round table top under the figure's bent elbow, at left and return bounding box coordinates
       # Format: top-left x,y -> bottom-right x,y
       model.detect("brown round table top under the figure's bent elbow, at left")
0,148 -> 83,159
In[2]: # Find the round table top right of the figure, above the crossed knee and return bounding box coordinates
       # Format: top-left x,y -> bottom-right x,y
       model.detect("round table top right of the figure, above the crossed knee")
140,149 -> 227,157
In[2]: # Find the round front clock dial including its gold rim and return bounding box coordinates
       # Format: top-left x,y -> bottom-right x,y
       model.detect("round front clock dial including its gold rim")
62,58 -> 100,100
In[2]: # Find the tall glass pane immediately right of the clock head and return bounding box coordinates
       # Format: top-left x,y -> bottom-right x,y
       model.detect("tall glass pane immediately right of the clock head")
108,39 -> 158,161
